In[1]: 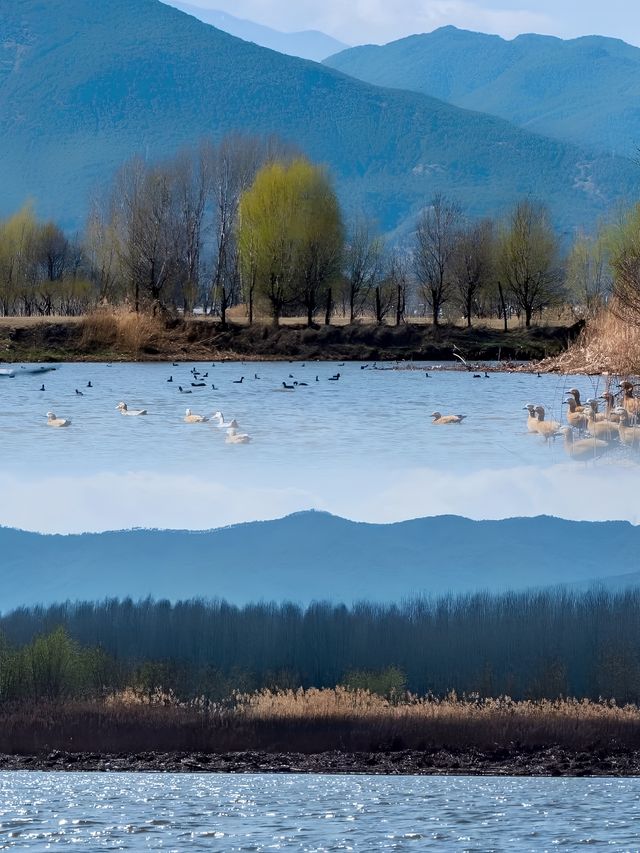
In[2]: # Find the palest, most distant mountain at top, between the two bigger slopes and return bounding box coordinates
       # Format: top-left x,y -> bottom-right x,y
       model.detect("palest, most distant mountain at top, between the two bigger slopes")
163,0 -> 348,62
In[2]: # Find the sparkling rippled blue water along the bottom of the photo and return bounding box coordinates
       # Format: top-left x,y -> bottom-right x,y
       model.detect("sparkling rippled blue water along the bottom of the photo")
0,773 -> 640,853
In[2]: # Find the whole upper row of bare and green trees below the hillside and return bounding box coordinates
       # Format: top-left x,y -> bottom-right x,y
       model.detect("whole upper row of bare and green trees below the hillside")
0,136 -> 640,328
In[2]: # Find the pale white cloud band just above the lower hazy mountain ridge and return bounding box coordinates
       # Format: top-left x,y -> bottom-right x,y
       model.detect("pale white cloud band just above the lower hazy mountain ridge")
0,463 -> 640,533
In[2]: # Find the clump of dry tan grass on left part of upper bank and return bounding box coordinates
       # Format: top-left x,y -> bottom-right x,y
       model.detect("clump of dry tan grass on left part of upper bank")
82,309 -> 165,354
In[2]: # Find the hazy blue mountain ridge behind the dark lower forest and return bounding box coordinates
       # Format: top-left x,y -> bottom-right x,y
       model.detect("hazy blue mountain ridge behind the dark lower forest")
0,512 -> 640,612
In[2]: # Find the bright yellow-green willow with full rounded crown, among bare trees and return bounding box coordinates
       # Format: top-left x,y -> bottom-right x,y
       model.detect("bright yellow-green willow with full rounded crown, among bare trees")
238,159 -> 344,326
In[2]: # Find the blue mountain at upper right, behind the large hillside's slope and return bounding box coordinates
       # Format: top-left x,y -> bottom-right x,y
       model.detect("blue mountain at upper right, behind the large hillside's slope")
326,27 -> 640,155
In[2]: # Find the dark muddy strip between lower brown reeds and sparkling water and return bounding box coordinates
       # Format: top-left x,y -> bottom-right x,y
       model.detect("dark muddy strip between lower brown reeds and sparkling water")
0,747 -> 640,777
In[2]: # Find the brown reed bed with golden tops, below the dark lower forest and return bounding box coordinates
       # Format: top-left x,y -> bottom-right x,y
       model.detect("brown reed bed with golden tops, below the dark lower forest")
0,687 -> 640,754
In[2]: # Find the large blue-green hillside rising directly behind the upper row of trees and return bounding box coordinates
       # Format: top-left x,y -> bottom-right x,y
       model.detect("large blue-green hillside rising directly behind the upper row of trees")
0,0 -> 640,232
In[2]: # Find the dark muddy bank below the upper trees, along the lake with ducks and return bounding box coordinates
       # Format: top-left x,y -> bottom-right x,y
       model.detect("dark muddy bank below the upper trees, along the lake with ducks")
0,318 -> 581,362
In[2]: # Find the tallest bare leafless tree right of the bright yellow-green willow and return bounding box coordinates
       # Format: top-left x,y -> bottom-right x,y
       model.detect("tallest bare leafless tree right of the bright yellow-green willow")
414,194 -> 460,326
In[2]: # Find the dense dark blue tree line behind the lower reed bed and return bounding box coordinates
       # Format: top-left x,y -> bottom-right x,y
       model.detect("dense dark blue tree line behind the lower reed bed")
0,589 -> 640,702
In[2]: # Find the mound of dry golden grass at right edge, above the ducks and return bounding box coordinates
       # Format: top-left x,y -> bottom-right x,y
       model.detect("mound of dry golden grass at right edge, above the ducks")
540,310 -> 640,376
